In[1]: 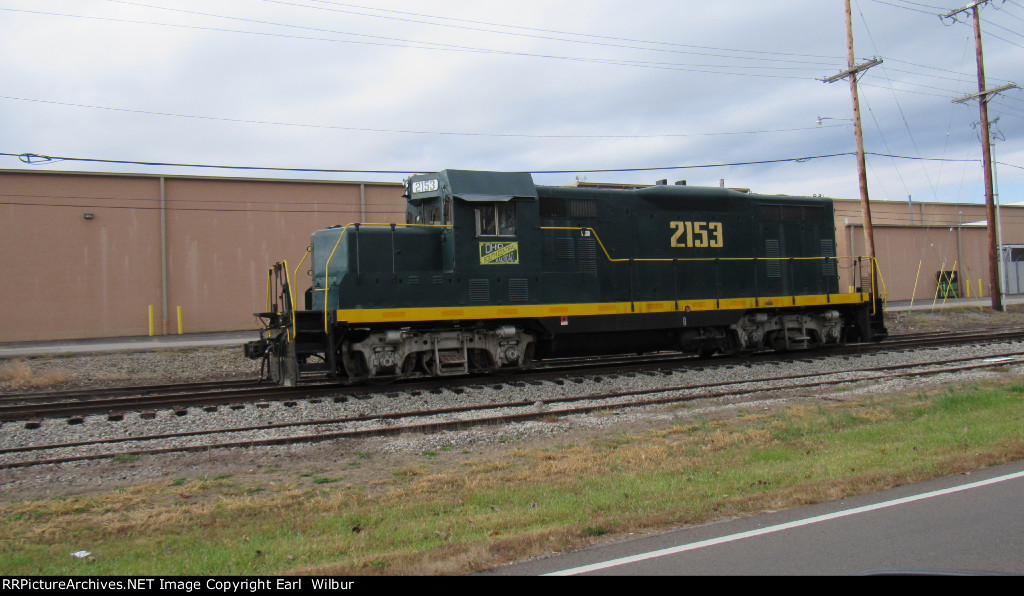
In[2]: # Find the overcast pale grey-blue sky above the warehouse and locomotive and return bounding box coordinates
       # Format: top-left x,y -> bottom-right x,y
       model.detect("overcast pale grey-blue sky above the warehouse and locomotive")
0,0 -> 1024,203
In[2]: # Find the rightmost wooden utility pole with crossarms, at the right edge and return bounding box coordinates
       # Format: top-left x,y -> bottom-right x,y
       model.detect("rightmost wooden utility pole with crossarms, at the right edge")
940,0 -> 1017,311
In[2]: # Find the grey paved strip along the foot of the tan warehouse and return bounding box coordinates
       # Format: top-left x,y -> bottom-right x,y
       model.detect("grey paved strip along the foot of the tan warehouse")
0,295 -> 1024,359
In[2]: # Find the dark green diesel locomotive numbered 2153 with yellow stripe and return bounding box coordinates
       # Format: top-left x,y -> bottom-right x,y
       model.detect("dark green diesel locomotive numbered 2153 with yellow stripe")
246,170 -> 886,385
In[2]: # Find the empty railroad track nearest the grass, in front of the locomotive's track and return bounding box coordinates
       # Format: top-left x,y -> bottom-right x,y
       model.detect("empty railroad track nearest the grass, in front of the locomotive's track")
0,349 -> 1024,469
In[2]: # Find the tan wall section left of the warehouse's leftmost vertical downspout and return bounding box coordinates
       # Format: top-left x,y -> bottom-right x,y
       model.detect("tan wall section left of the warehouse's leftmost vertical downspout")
0,175 -> 160,341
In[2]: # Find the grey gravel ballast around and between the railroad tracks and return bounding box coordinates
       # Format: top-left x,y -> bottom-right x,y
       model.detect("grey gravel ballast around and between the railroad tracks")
6,313 -> 1024,497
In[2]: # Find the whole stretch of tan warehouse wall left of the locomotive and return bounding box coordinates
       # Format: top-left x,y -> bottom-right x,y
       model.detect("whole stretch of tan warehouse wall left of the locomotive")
0,171 -> 404,342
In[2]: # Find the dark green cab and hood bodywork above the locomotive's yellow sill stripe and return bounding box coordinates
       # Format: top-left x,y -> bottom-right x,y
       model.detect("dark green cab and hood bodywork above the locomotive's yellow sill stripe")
312,170 -> 839,310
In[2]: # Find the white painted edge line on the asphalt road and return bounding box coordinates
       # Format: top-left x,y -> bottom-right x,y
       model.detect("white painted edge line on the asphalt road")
545,471 -> 1024,576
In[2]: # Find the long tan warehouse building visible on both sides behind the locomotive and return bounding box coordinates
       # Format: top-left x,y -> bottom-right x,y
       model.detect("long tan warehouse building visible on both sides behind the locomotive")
0,170 -> 1024,342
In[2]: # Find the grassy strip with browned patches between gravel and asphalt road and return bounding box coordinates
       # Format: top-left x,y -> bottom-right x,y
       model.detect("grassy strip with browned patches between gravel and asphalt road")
0,381 -> 1024,576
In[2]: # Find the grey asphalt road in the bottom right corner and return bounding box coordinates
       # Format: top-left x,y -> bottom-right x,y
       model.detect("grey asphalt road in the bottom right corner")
483,462 -> 1024,576
